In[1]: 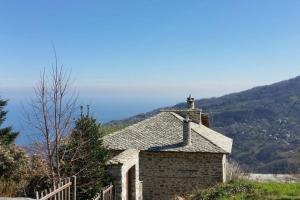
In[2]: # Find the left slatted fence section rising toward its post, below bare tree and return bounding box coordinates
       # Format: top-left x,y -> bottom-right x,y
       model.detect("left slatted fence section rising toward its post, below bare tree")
36,176 -> 76,200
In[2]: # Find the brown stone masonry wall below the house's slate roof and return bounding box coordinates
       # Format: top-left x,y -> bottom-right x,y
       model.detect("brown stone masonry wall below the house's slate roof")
140,152 -> 226,200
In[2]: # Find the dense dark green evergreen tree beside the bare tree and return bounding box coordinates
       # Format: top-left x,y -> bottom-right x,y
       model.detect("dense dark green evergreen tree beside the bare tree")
63,108 -> 108,199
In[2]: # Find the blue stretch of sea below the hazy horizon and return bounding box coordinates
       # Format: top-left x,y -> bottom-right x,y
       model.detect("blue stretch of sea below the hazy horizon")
1,95 -> 178,146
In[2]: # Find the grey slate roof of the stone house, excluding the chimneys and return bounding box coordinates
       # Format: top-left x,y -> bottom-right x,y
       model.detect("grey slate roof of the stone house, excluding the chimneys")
103,112 -> 232,153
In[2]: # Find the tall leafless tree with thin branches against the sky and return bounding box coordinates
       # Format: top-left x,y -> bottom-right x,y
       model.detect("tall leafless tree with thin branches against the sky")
26,50 -> 77,179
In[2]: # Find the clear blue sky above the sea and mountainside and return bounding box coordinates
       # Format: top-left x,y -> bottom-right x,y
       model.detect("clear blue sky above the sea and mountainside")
0,0 -> 300,103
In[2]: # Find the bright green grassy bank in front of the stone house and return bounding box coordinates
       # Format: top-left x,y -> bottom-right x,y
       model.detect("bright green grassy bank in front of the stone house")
187,180 -> 300,200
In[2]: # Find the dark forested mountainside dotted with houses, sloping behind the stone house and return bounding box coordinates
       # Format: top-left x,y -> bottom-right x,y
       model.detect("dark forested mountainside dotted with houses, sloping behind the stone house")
112,77 -> 300,173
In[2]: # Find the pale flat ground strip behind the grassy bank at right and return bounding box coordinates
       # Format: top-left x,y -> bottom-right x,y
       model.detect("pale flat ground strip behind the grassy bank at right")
249,174 -> 300,182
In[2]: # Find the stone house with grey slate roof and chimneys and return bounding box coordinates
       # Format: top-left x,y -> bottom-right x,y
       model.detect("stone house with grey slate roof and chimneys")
103,96 -> 232,200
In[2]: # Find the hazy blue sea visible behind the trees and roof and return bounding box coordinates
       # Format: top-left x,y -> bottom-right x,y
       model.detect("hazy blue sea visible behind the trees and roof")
4,97 -> 173,146
